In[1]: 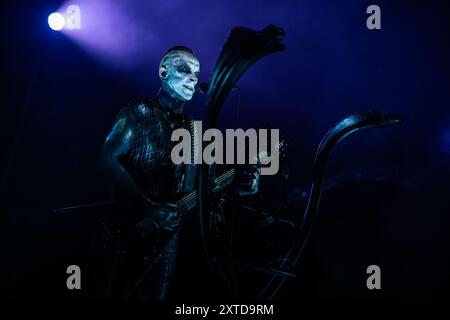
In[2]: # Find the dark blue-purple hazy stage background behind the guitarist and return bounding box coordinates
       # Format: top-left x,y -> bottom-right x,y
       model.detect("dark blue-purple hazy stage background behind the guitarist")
0,0 -> 450,300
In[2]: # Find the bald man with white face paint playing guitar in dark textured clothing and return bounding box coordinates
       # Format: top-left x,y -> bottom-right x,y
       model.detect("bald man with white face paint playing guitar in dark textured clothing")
100,46 -> 259,300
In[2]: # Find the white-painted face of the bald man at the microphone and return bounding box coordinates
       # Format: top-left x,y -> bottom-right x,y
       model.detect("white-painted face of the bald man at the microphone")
160,51 -> 200,101
